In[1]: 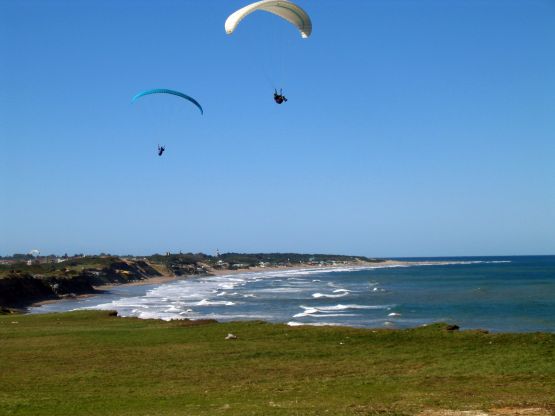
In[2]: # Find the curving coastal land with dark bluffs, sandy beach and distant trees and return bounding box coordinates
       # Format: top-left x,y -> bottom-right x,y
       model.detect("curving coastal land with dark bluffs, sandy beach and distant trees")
6,253 -> 466,313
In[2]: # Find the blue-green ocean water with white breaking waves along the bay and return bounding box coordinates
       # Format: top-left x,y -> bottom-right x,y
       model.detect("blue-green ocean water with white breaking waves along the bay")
30,256 -> 555,332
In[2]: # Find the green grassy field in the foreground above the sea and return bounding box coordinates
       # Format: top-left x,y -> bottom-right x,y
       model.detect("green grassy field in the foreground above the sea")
0,312 -> 555,416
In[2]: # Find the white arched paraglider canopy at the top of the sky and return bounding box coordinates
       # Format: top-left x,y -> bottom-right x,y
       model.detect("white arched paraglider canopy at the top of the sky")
225,0 -> 312,38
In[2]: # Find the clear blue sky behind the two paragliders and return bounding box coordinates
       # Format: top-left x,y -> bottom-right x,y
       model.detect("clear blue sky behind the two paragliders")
0,0 -> 555,257
